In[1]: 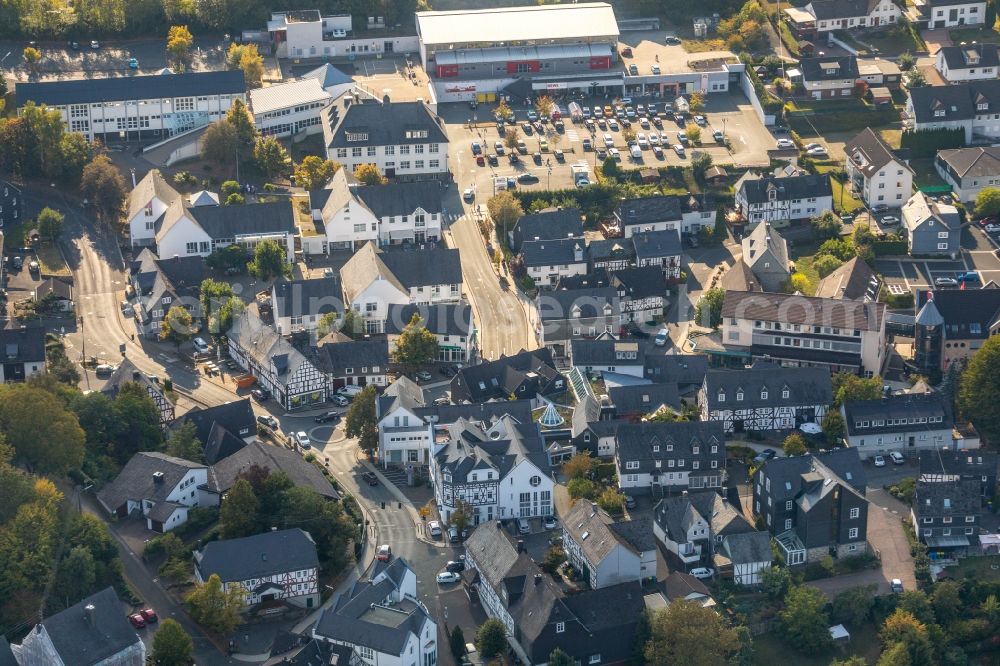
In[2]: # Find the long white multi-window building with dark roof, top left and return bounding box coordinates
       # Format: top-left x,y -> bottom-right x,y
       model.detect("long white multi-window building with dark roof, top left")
17,69 -> 247,144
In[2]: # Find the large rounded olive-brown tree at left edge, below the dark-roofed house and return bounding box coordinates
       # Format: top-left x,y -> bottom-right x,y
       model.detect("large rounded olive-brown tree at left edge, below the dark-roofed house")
0,383 -> 86,472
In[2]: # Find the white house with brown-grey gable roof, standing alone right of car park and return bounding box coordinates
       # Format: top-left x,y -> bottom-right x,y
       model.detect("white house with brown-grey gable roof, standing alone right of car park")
844,127 -> 913,208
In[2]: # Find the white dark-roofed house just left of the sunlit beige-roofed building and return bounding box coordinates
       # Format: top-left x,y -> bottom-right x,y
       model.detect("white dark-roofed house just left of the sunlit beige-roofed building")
271,276 -> 343,336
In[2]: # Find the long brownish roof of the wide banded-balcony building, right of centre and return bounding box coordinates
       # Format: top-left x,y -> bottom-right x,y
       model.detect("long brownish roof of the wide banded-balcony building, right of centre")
722,291 -> 886,331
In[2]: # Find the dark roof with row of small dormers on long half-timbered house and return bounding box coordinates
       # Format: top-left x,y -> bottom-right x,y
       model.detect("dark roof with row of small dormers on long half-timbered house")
705,361 -> 833,410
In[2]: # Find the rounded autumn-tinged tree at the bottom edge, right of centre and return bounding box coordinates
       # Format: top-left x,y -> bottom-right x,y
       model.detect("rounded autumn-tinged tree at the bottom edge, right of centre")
646,599 -> 739,666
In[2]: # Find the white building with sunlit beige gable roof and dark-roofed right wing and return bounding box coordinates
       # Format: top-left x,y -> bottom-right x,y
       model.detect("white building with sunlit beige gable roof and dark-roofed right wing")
340,243 -> 462,333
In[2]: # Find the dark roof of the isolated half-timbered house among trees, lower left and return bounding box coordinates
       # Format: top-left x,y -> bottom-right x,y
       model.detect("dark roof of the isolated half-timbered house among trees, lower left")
194,528 -> 319,583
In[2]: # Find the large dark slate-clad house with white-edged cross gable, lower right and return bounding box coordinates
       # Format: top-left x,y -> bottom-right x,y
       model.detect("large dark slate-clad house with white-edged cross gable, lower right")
753,448 -> 868,566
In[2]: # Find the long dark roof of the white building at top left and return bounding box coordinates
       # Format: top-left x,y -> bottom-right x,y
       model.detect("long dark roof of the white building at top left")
15,69 -> 247,106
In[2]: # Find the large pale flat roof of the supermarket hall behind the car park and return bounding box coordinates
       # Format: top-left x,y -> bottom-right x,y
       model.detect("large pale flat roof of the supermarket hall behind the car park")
417,2 -> 619,44
